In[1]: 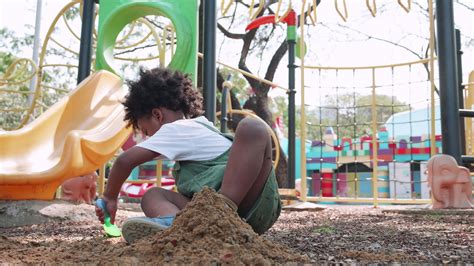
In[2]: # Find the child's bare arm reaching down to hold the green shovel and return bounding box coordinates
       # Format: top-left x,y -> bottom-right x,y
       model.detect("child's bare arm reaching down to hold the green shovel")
96,146 -> 160,223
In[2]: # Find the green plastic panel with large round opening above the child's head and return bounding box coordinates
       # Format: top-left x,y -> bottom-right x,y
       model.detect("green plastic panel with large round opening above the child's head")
96,0 -> 198,82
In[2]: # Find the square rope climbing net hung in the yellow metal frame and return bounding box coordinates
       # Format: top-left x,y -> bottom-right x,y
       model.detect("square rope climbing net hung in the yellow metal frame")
305,61 -> 441,199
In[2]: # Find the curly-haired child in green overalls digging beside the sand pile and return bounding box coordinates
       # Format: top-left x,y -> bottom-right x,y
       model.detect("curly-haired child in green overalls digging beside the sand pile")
96,68 -> 281,243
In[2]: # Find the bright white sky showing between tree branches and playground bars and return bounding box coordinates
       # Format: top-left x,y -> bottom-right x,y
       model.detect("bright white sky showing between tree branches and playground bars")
0,0 -> 474,109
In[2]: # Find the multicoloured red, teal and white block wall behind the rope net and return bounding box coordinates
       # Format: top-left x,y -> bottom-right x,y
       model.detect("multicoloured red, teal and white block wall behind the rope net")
282,127 -> 441,199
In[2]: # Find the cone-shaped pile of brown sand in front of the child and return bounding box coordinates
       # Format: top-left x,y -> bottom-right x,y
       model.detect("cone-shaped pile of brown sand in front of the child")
102,189 -> 309,264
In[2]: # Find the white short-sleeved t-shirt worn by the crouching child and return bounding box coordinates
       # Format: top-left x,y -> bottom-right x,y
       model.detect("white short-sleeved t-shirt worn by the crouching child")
137,116 -> 232,161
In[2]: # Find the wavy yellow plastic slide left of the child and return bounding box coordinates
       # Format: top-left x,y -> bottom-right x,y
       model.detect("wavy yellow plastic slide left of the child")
0,71 -> 130,200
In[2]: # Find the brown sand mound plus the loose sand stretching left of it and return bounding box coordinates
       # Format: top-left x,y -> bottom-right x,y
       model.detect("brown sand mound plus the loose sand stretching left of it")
0,189 -> 309,265
